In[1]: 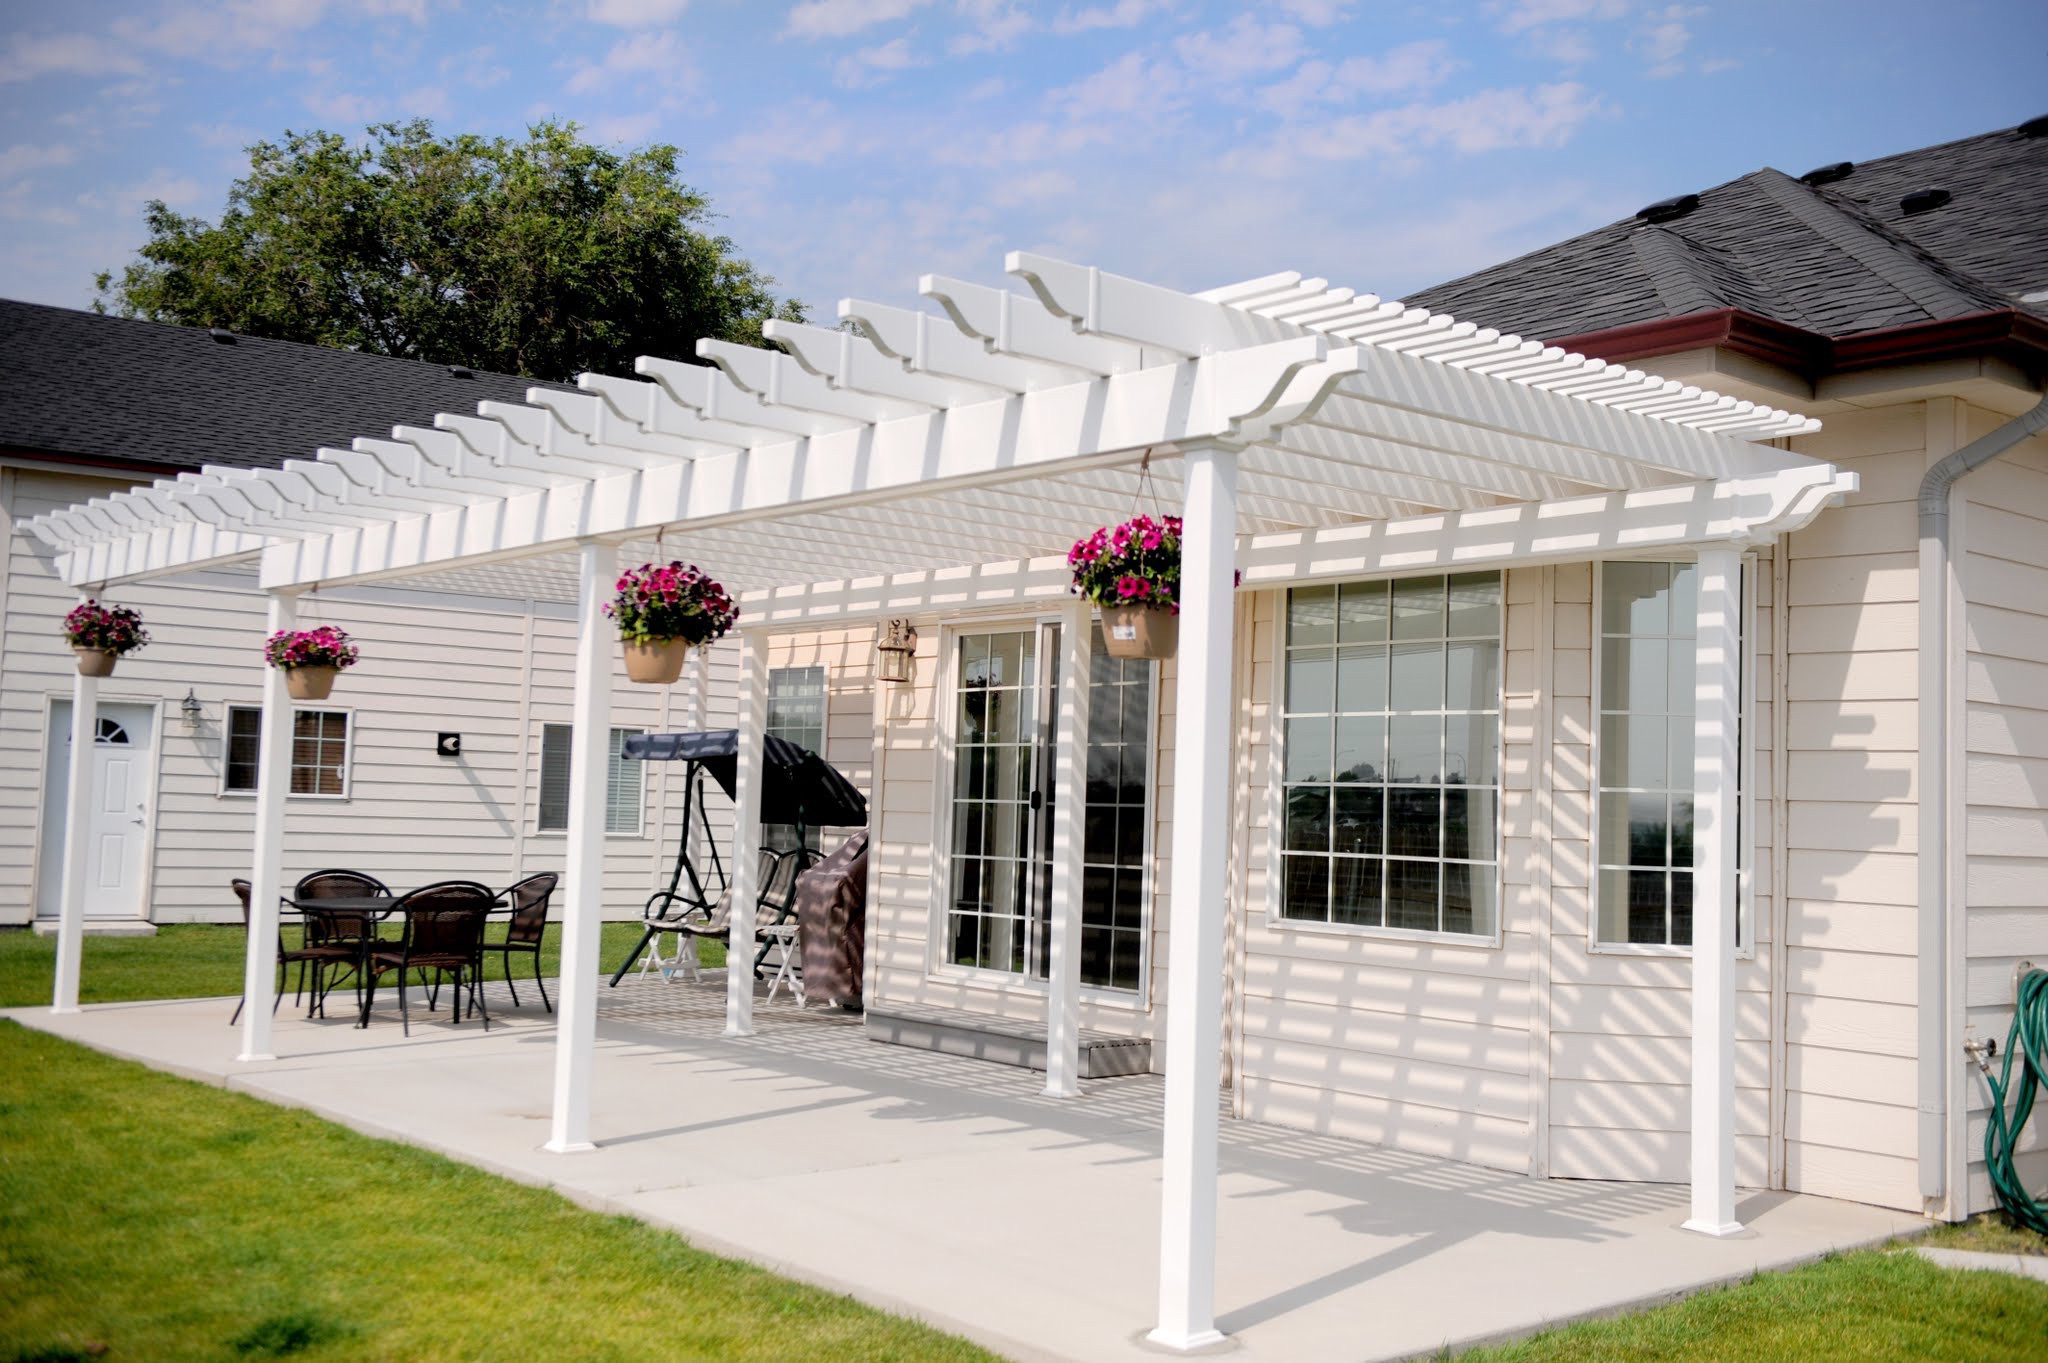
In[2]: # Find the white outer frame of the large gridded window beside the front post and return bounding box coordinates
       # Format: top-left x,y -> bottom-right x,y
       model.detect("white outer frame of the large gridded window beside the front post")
1264,569 -> 1507,952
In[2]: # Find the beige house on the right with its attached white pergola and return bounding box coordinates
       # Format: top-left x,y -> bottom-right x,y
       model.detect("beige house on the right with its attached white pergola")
27,123 -> 2048,1347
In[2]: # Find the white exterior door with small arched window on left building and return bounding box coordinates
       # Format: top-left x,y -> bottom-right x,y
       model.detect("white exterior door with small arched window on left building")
35,700 -> 156,919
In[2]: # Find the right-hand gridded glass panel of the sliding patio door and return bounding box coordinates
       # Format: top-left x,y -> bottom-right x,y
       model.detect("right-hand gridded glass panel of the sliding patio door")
1081,624 -> 1153,991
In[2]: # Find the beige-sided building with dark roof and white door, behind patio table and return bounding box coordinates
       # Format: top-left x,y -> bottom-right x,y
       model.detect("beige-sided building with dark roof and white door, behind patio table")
0,301 -> 753,931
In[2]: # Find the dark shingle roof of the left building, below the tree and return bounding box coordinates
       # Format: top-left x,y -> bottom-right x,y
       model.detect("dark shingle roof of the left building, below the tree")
0,299 -> 557,469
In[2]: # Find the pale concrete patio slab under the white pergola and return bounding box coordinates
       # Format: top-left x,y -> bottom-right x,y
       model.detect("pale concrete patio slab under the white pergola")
6,972 -> 1921,1363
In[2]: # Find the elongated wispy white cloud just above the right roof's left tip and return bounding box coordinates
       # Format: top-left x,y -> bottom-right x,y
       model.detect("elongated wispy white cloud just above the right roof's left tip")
1294,82 -> 1606,160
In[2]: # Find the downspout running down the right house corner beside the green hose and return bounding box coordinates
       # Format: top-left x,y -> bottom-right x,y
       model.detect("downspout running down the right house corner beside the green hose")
1917,384 -> 2048,1199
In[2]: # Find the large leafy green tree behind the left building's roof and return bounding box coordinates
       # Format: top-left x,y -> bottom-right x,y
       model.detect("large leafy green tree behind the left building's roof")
94,121 -> 803,381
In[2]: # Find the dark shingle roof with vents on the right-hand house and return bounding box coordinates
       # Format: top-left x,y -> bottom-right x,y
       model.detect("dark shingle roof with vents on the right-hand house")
1409,125 -> 2048,340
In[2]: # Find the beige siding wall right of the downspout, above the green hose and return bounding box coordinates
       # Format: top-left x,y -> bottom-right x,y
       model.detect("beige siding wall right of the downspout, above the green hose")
1954,419 -> 2048,1212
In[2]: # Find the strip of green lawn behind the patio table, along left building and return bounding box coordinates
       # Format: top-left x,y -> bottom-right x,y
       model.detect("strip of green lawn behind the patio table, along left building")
0,923 -> 725,1007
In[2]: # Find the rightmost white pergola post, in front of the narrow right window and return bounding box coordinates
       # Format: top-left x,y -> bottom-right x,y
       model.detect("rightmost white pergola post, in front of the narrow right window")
1686,546 -> 1743,1236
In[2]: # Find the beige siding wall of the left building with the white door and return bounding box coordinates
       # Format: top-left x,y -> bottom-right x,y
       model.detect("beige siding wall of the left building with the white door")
0,469 -> 733,923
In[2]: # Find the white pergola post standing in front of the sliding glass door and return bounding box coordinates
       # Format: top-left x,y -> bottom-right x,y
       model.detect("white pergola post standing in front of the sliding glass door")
1044,598 -> 1096,1097
